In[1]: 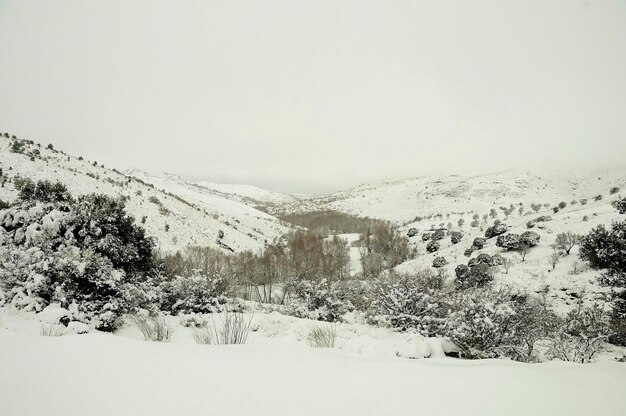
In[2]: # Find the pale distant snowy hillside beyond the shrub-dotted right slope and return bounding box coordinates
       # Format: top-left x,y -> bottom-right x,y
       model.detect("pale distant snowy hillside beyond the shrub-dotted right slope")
286,169 -> 626,223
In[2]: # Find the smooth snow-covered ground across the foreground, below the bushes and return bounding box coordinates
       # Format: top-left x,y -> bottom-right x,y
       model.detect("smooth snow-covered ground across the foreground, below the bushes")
0,309 -> 626,416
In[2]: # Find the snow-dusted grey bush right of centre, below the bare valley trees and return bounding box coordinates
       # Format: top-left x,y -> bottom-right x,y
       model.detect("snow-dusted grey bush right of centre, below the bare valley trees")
371,270 -> 449,336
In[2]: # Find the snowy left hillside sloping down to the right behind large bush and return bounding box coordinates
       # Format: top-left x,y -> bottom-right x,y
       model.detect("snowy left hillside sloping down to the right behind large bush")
0,137 -> 286,252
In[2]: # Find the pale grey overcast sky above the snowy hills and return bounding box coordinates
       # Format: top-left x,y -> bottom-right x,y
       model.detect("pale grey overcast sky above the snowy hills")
0,0 -> 626,193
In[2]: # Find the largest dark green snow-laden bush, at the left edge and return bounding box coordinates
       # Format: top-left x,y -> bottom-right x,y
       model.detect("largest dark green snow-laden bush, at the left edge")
0,184 -> 153,330
